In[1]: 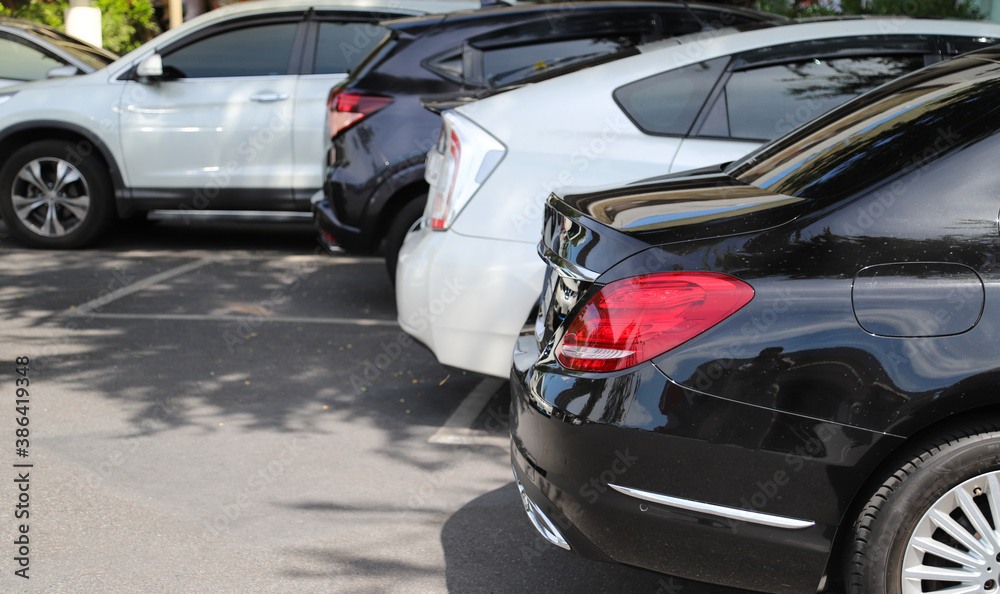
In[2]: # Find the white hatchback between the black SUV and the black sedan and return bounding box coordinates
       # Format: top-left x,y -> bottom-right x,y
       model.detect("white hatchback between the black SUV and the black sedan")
396,18 -> 1000,377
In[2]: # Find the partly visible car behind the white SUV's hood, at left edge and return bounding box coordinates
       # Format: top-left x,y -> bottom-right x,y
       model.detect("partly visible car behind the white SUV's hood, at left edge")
0,17 -> 118,86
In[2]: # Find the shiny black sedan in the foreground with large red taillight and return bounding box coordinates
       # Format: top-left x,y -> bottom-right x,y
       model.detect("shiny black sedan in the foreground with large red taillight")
511,48 -> 1000,594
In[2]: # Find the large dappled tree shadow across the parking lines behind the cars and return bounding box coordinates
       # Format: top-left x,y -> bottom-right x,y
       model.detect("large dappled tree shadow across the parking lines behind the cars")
0,215 -> 478,469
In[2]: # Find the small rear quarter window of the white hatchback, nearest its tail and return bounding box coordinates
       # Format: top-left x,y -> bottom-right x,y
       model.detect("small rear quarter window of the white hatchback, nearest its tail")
614,57 -> 729,135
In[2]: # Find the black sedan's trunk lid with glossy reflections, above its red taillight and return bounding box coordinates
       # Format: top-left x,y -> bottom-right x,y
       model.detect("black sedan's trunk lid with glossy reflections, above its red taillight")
535,168 -> 808,346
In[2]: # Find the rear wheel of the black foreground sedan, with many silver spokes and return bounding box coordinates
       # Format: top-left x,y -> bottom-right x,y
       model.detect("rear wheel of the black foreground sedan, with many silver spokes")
845,423 -> 1000,594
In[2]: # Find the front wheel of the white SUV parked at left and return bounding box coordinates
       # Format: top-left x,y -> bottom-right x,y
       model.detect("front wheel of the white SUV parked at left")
0,140 -> 114,249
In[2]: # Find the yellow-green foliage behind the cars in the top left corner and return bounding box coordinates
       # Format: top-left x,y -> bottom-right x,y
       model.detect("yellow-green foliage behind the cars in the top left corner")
0,0 -> 160,54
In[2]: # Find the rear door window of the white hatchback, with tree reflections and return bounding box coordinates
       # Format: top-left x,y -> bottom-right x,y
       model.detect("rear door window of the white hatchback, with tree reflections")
720,54 -> 924,140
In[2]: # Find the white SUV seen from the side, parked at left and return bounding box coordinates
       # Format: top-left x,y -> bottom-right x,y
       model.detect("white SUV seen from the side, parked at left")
0,0 -> 479,248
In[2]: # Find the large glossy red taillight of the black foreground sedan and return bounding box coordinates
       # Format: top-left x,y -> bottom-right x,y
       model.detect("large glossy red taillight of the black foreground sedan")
556,272 -> 753,372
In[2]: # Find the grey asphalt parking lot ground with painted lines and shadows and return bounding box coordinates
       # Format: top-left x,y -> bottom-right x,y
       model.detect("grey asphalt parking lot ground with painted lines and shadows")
0,216 -> 752,594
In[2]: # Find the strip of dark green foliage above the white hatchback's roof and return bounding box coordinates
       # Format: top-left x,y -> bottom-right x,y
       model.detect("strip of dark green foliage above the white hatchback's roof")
755,0 -> 986,20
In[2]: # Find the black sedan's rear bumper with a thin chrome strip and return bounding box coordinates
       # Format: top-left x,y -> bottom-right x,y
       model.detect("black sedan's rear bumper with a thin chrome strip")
511,338 -> 904,593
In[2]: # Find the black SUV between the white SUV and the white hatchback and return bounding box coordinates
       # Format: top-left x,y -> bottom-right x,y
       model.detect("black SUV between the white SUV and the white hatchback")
314,2 -> 784,278
